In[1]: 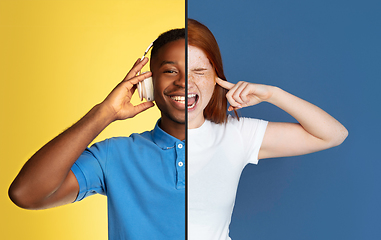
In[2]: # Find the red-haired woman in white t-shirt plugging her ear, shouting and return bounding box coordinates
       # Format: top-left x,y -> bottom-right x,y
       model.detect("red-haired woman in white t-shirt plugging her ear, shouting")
187,19 -> 348,240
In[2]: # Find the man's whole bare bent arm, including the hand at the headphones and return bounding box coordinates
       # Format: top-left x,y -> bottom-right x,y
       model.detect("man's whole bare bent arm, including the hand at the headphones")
9,58 -> 154,209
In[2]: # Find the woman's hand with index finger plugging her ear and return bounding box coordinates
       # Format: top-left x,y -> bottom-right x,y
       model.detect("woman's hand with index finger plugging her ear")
216,78 -> 274,111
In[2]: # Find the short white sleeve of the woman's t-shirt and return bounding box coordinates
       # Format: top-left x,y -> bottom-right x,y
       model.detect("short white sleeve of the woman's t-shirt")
229,117 -> 268,164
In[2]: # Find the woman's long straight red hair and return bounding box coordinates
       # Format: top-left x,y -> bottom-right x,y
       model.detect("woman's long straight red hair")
188,19 -> 228,123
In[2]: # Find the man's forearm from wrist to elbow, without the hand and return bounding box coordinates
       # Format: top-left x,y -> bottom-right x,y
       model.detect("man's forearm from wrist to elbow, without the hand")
9,105 -> 112,206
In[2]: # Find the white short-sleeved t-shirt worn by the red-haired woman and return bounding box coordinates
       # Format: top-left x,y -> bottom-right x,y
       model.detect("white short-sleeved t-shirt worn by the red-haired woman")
187,117 -> 267,240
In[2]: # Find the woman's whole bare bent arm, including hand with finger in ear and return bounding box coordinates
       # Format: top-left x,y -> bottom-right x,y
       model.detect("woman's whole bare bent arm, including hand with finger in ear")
216,78 -> 348,159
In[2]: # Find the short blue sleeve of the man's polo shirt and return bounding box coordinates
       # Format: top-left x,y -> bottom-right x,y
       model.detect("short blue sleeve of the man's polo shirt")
71,140 -> 109,201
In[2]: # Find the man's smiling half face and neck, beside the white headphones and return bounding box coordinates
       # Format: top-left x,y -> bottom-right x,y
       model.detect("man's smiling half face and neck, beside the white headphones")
151,39 -> 186,134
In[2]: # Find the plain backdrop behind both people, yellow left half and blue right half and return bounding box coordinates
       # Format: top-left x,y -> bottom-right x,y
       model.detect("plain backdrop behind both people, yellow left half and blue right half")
0,0 -> 381,240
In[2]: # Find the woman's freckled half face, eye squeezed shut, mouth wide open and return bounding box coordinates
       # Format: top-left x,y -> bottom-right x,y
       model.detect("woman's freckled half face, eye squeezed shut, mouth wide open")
188,45 -> 216,129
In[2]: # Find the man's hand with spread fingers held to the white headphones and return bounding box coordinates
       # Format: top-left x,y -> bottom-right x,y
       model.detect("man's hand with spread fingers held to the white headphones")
101,58 -> 154,121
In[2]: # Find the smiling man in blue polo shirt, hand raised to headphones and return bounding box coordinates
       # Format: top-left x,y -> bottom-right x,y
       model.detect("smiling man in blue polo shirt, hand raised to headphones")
9,29 -> 186,240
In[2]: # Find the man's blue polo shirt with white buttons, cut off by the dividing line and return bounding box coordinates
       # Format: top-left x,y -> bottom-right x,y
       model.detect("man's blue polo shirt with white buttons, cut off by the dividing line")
71,120 -> 185,240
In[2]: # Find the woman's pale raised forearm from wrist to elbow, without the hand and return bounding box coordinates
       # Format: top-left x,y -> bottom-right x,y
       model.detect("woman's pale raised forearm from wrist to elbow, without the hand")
268,87 -> 348,147
